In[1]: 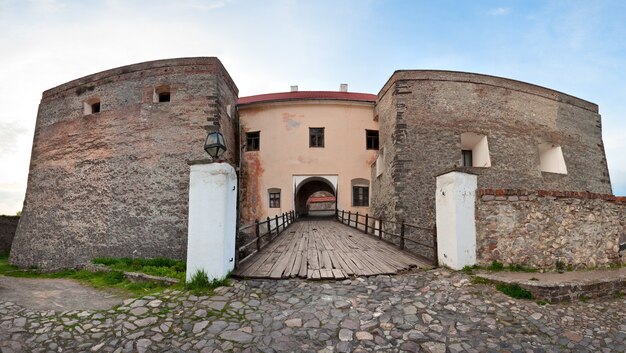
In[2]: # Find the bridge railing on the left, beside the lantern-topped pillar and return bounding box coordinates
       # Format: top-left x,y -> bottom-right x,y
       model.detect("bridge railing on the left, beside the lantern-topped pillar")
235,211 -> 298,268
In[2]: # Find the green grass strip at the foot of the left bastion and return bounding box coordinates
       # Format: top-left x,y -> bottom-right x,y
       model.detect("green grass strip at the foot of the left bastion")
0,254 -> 185,295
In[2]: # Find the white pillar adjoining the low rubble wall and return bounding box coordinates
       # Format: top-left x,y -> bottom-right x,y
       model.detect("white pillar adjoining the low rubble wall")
436,171 -> 477,270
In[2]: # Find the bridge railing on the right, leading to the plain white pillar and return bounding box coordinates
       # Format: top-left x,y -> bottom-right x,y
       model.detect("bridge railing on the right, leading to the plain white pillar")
335,210 -> 438,266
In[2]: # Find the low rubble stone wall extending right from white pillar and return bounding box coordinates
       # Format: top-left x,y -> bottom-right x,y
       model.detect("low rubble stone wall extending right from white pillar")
476,189 -> 626,269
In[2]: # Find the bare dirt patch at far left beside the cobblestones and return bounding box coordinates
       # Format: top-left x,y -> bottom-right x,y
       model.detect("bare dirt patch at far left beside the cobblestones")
0,276 -> 126,311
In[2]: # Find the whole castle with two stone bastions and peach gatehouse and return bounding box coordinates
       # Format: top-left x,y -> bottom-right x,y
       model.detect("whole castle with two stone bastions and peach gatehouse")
10,57 -> 622,268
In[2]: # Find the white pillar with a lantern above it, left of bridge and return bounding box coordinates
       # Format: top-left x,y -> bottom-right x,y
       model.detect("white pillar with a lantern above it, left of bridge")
187,163 -> 237,281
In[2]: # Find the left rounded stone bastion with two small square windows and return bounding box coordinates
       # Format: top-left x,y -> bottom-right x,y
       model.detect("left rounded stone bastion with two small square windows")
10,58 -> 238,269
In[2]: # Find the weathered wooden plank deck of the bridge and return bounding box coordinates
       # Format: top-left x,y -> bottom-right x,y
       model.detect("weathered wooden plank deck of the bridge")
233,219 -> 432,279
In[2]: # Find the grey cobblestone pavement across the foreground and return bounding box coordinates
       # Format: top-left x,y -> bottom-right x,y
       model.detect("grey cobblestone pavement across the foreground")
0,269 -> 626,353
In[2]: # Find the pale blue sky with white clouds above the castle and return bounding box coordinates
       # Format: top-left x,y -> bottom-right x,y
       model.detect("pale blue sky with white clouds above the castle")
0,0 -> 626,214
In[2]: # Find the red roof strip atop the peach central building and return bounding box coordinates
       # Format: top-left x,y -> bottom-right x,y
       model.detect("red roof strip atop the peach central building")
237,91 -> 377,105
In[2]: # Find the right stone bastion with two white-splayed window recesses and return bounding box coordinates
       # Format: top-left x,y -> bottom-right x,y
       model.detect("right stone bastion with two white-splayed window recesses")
372,70 -> 612,245
